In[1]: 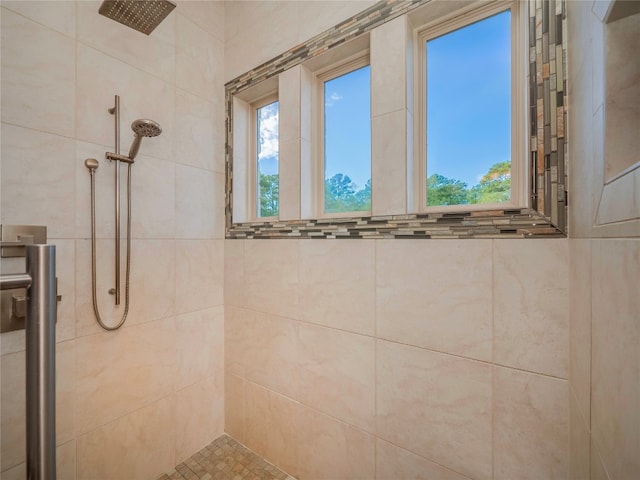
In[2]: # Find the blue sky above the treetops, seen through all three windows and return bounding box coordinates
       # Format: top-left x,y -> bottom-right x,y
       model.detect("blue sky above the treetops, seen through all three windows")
259,11 -> 511,187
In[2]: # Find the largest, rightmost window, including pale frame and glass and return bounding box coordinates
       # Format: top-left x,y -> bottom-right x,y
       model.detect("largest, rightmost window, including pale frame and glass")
418,0 -> 526,211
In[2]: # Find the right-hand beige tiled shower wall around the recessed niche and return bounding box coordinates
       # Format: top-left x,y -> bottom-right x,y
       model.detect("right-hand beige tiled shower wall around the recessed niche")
567,1 -> 640,480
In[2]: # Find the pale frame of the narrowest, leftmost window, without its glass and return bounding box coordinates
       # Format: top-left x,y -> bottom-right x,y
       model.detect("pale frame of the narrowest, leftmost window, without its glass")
247,92 -> 280,221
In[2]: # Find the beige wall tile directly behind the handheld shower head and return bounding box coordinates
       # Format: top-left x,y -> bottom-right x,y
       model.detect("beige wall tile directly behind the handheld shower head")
75,45 -> 175,160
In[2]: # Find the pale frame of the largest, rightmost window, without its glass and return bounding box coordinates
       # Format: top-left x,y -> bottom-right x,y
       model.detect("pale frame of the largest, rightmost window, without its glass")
413,0 -> 529,213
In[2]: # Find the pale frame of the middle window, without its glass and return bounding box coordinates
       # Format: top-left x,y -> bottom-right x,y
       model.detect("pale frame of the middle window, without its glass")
312,50 -> 373,218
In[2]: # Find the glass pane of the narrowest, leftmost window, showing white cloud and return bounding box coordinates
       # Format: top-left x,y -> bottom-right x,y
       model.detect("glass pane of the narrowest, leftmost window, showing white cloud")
256,102 -> 278,217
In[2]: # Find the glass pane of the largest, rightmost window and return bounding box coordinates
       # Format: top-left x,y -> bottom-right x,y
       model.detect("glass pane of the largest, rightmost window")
426,11 -> 511,206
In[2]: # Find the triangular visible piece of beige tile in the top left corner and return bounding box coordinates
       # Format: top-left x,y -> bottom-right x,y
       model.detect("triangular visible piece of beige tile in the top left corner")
2,0 -> 76,38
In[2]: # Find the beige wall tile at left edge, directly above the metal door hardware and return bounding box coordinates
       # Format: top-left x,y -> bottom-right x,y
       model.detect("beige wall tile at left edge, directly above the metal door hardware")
1,123 -> 75,238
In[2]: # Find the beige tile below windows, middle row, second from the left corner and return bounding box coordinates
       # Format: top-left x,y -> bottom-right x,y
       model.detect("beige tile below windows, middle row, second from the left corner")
242,312 -> 300,400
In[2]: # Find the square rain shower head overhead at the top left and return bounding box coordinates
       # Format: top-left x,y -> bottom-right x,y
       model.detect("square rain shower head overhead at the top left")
98,0 -> 176,35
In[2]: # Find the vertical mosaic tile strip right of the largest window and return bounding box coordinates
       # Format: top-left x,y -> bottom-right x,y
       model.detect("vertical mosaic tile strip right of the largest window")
529,0 -> 568,231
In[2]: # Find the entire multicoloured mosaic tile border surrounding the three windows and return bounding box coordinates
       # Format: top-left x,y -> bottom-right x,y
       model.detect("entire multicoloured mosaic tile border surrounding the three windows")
225,0 -> 567,239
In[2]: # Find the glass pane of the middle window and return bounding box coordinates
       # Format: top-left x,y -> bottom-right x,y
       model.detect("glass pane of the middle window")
324,66 -> 371,213
